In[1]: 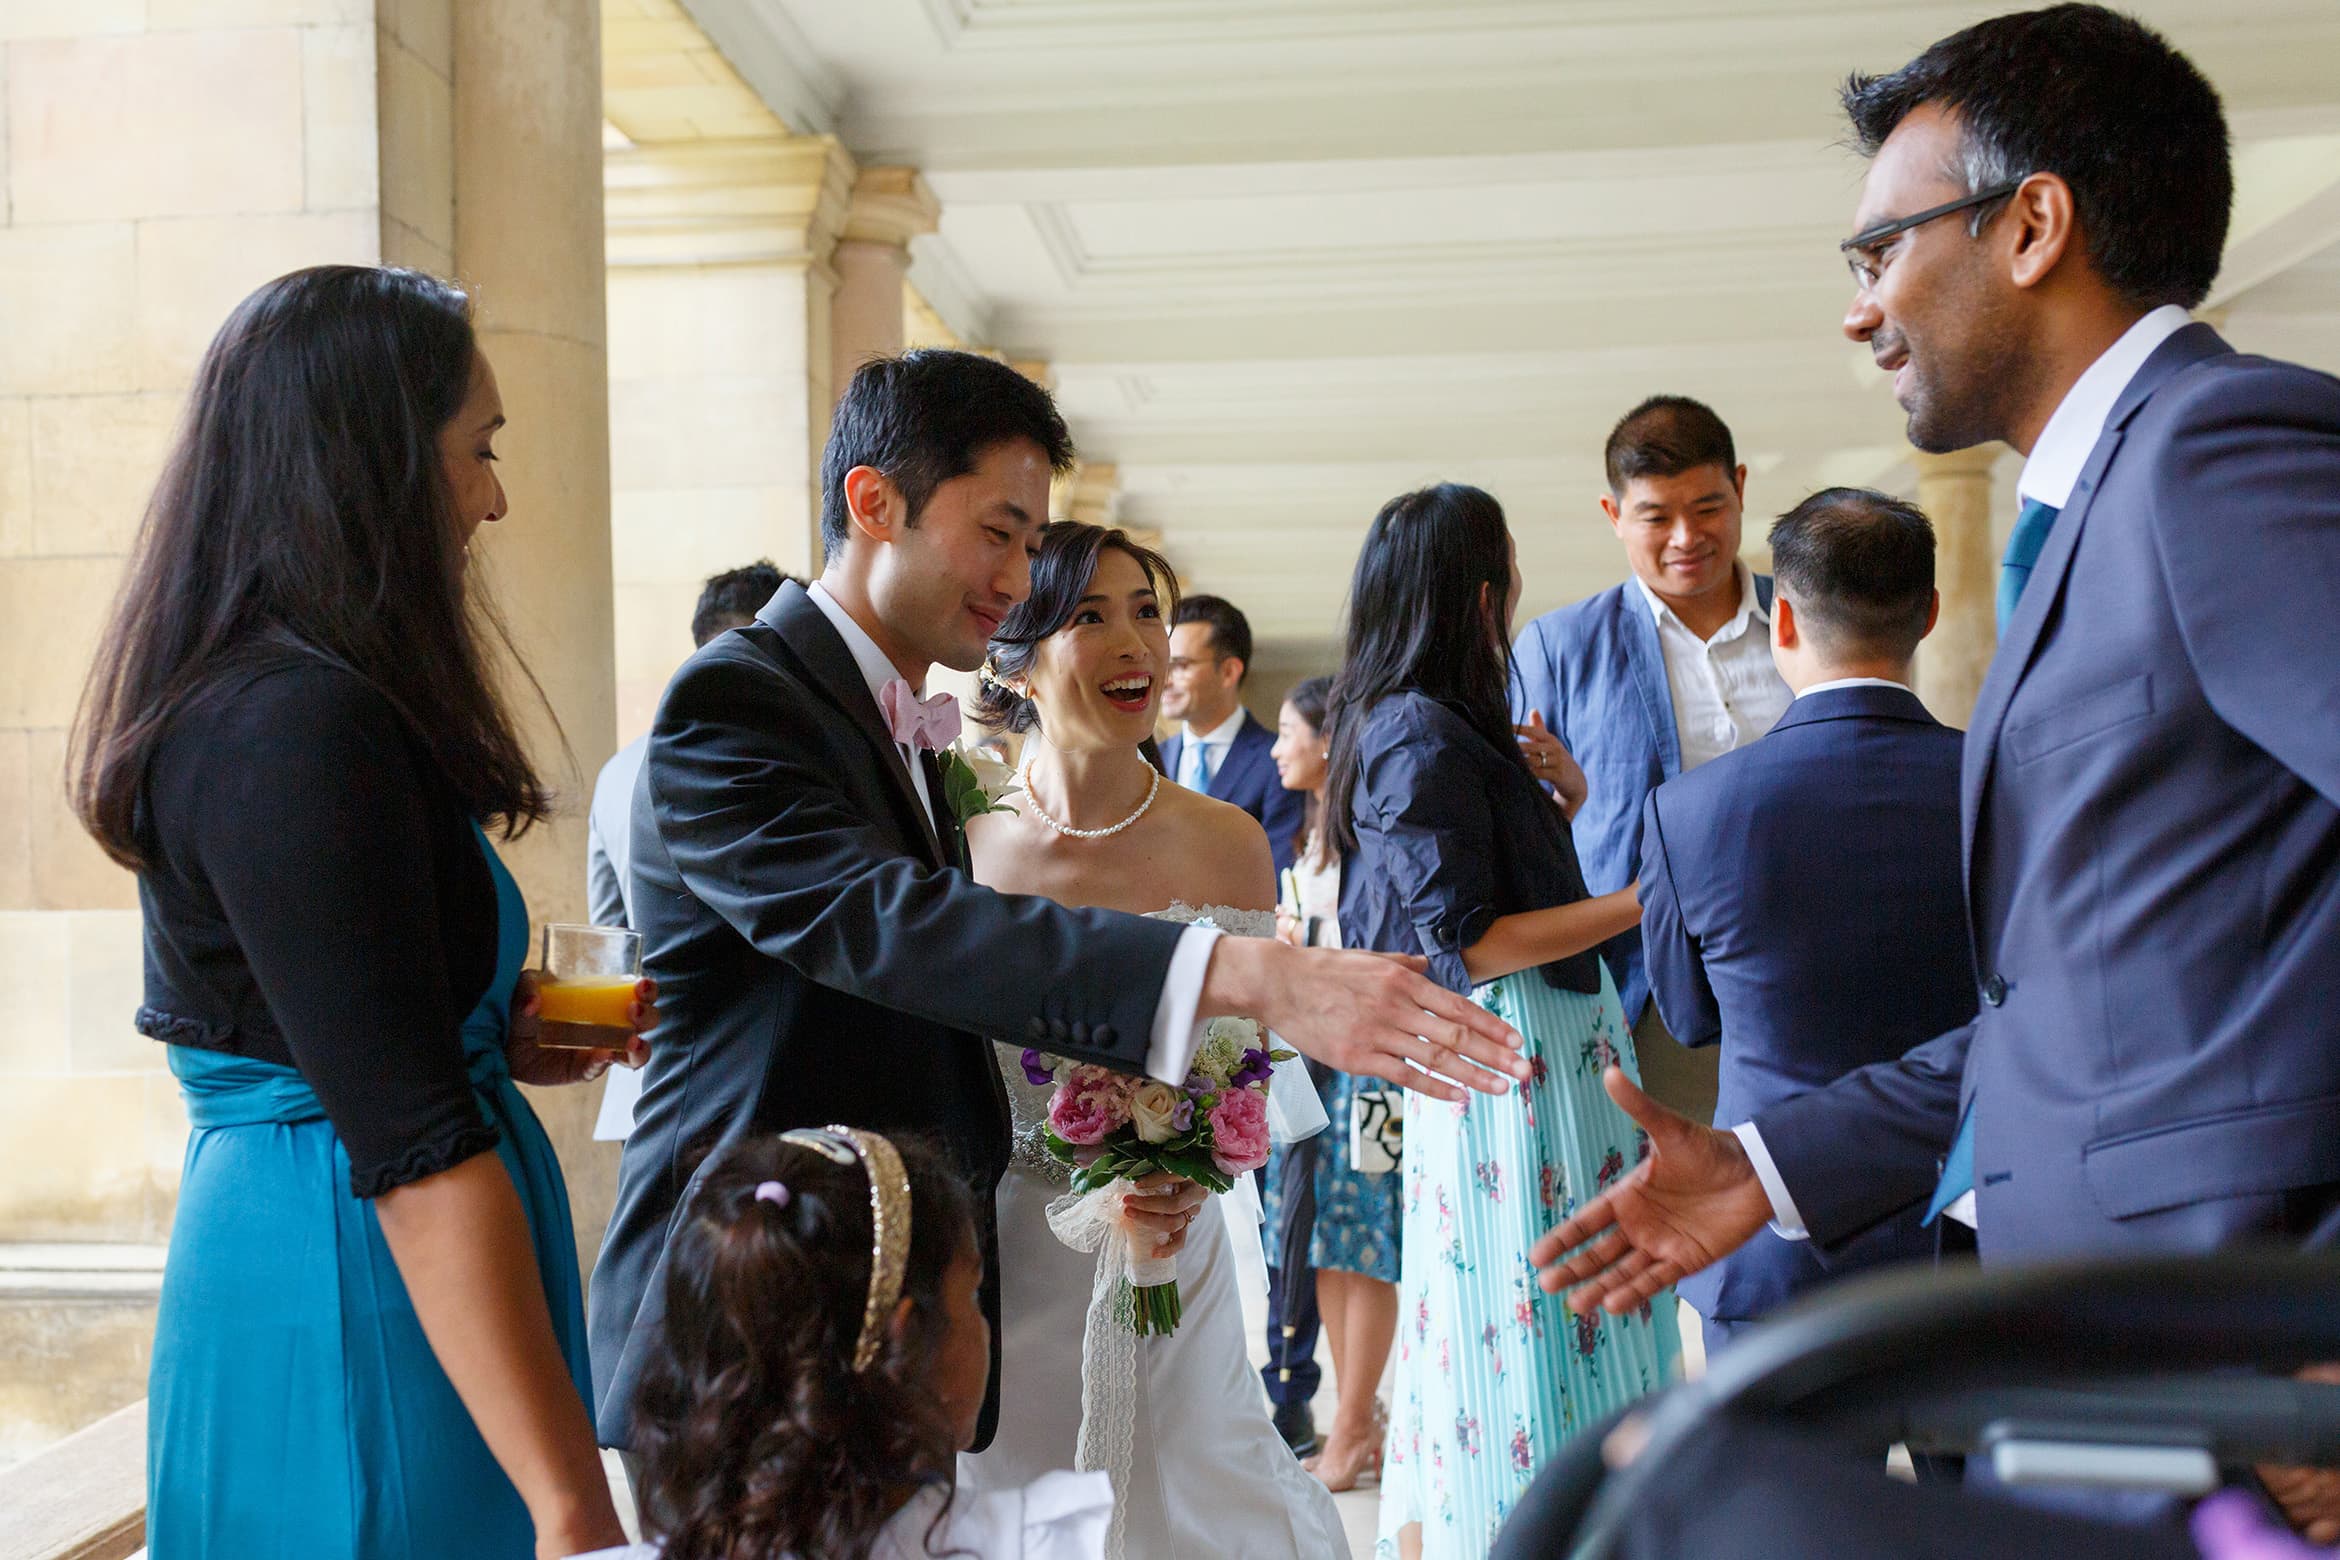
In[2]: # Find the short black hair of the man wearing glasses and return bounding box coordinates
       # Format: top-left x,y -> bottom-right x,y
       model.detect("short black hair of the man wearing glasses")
1844,5 -> 2235,309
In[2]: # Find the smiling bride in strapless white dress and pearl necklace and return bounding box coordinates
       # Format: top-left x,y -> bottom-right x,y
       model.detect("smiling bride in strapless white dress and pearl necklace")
959,524 -> 1348,1560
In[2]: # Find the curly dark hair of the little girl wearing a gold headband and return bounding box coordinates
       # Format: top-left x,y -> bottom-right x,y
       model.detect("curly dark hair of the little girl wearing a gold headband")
634,1137 -> 976,1560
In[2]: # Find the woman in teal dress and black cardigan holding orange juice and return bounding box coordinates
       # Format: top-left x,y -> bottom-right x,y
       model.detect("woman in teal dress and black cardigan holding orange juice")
73,267 -> 653,1560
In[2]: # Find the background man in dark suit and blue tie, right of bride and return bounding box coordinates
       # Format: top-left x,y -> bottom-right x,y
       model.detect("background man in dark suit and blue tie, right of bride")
1163,596 -> 1308,875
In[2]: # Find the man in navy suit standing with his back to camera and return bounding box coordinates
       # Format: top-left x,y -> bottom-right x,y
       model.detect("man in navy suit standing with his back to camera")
1640,489 -> 1975,1357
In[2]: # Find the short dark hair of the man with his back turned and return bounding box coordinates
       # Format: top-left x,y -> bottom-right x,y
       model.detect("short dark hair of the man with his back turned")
1771,486 -> 1933,662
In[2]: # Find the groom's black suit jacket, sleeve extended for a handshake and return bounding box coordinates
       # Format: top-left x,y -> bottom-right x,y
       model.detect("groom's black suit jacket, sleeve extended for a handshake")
590,585 -> 1184,1445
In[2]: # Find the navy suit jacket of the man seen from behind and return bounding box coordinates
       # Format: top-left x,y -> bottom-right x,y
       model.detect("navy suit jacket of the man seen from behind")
1640,688 -> 1975,1321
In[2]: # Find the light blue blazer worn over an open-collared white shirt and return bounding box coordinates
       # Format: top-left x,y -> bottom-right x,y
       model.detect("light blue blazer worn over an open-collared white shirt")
1512,575 -> 1771,1024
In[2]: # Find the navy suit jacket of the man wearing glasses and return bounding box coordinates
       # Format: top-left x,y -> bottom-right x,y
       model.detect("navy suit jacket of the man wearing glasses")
1755,325 -> 2340,1261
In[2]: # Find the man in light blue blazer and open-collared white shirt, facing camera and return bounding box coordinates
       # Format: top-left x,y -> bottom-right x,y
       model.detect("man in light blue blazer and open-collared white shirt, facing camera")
1512,395 -> 1788,1116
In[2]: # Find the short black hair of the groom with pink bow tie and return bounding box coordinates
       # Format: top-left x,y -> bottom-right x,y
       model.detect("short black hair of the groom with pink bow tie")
821,346 -> 1072,557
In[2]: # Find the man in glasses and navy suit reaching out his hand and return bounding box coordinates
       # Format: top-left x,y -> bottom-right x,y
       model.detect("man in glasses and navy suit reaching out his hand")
1535,5 -> 2340,1553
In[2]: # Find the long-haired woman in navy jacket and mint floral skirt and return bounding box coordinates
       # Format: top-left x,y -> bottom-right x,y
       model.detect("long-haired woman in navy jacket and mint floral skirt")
1324,484 -> 1680,1558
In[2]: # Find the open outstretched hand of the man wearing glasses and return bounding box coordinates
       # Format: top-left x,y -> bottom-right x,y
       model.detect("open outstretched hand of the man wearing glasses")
1528,1067 -> 1771,1314
